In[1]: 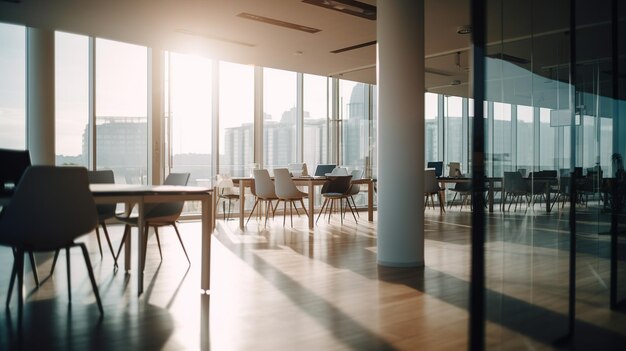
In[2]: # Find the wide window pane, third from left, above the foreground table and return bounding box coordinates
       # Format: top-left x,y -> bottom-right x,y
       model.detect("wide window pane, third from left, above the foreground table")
96,39 -> 148,184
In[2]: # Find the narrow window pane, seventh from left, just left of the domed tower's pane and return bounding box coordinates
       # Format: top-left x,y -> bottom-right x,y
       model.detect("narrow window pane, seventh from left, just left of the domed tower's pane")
303,74 -> 328,173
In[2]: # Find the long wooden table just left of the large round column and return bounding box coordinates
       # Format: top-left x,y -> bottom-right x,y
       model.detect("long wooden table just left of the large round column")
233,177 -> 374,230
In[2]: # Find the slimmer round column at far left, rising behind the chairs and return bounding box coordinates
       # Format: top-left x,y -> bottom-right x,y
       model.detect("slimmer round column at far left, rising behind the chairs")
26,28 -> 55,165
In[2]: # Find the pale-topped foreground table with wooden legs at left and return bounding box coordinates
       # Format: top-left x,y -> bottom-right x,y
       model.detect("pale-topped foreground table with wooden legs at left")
90,184 -> 213,295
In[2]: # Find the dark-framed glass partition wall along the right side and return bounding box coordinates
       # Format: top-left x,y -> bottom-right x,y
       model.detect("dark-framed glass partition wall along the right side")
472,0 -> 626,349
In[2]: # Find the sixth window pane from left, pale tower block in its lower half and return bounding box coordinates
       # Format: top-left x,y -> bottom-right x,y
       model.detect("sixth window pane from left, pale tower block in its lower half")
263,68 -> 298,168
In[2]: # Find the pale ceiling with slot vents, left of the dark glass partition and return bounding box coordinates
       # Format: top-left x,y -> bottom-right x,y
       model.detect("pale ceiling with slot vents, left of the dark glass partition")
0,0 -> 470,96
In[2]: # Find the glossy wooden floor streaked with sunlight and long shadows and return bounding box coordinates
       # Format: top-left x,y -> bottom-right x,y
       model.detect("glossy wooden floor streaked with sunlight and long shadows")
0,205 -> 626,351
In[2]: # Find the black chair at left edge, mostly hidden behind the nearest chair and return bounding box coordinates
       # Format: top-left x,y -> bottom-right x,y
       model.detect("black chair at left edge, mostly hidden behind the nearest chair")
0,149 -> 39,292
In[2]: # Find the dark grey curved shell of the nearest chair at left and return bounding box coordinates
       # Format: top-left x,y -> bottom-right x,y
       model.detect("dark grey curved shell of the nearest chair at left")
0,166 -> 97,250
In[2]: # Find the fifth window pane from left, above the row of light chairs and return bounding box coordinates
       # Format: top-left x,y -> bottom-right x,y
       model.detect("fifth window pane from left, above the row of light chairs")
218,62 -> 254,177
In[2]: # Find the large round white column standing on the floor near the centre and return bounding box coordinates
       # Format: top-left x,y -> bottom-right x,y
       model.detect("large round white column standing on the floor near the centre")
377,0 -> 425,267
